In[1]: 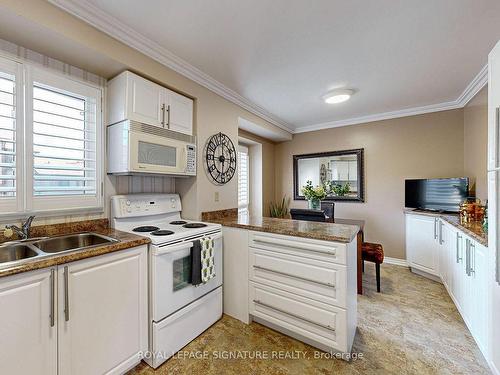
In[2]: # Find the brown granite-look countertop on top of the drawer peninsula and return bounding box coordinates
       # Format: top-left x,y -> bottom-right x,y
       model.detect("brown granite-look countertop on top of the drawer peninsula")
211,215 -> 360,243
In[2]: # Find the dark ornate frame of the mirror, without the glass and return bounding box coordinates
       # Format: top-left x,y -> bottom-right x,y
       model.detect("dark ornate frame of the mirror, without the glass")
293,148 -> 365,202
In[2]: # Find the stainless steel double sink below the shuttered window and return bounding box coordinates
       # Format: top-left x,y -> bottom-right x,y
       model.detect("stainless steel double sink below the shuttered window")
0,232 -> 119,267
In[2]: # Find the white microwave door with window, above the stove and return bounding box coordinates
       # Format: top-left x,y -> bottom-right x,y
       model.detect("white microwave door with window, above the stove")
130,131 -> 187,174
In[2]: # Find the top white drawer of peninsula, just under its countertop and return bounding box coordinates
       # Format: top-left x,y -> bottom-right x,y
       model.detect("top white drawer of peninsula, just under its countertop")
248,232 -> 346,264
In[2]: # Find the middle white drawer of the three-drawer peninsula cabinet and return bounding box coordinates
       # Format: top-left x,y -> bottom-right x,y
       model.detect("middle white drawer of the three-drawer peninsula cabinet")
249,247 -> 347,308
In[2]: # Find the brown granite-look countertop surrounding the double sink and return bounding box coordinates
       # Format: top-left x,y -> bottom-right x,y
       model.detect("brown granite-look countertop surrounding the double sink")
0,222 -> 150,277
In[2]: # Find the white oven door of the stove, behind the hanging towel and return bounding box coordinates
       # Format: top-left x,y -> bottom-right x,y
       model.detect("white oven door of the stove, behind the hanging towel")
151,233 -> 222,322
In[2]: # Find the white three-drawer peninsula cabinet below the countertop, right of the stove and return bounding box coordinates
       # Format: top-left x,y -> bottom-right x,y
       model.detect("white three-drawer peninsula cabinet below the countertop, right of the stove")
248,232 -> 357,353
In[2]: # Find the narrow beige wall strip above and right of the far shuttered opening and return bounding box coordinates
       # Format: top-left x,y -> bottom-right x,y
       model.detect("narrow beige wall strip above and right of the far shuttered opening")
238,129 -> 278,216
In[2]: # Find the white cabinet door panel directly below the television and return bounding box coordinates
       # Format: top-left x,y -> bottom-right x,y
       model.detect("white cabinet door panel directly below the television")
406,215 -> 439,276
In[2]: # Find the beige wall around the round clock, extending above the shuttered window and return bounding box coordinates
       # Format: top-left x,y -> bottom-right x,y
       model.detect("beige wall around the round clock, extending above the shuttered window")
0,0 -> 290,218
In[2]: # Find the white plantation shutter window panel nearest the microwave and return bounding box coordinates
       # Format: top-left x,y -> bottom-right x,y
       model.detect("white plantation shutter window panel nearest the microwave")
30,70 -> 100,210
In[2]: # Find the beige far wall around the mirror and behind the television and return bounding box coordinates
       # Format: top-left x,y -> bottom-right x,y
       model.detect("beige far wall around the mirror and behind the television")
275,109 -> 464,258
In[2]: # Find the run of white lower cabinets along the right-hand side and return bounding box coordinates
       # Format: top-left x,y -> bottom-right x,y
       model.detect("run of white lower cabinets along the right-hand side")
406,213 -> 489,359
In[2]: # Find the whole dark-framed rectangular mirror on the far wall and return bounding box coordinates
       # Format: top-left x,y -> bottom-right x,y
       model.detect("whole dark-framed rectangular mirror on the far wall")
293,148 -> 365,202
